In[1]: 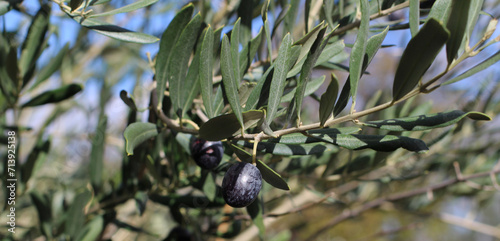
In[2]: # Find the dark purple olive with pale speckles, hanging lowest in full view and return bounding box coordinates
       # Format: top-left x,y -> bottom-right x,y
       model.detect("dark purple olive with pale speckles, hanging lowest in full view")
222,162 -> 262,208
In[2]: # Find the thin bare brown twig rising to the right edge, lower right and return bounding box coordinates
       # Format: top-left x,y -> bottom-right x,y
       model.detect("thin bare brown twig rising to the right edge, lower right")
307,169 -> 500,240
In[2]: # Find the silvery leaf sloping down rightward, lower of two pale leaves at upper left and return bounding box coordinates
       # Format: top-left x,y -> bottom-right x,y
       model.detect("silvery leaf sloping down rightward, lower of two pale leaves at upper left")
71,16 -> 158,44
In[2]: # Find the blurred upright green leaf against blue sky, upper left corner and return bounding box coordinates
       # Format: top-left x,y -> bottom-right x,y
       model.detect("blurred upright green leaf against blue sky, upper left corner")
19,4 -> 50,83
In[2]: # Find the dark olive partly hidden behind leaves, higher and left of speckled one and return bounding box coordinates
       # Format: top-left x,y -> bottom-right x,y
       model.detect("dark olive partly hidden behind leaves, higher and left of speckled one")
191,138 -> 224,170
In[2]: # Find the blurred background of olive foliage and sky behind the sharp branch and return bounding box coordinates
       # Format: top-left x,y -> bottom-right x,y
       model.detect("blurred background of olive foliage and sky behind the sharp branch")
0,0 -> 500,240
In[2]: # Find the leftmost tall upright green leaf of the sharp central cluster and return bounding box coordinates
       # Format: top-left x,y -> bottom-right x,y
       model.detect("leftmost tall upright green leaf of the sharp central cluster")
167,14 -> 201,118
